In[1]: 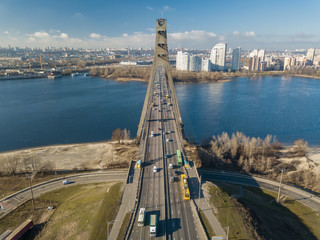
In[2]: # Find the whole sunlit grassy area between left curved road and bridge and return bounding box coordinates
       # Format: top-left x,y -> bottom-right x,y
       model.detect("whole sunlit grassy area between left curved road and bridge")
36,183 -> 122,239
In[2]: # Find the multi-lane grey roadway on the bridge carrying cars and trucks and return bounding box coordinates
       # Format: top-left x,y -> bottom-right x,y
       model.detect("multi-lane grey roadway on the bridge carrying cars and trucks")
129,67 -> 198,240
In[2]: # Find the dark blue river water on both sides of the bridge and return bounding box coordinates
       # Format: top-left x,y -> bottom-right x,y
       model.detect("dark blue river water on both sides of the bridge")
0,76 -> 320,151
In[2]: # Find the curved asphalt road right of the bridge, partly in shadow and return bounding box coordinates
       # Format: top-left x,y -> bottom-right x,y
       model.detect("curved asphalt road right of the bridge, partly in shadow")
198,170 -> 320,212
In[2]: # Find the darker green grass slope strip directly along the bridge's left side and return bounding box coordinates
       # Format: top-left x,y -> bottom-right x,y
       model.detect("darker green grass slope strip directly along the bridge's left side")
90,183 -> 122,240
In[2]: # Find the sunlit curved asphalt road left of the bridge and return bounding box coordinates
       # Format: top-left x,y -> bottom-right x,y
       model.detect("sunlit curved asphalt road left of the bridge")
0,170 -> 127,217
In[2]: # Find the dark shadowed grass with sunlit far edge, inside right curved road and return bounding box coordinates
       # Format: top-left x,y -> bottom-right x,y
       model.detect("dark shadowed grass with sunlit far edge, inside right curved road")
210,184 -> 320,239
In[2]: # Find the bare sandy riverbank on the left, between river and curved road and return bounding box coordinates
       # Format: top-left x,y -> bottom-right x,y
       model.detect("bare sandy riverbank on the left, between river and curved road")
0,140 -> 138,174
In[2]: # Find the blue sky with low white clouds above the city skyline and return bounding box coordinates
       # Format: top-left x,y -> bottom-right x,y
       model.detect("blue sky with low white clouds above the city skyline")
0,0 -> 320,49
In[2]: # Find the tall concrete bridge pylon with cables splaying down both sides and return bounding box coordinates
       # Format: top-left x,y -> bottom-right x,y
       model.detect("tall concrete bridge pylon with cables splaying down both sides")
137,18 -> 184,140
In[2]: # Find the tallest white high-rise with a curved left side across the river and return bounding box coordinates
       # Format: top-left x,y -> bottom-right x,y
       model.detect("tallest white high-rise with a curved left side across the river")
210,43 -> 227,70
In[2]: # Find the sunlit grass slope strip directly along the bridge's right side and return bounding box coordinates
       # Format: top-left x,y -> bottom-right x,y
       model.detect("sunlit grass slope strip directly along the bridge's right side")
209,186 -> 256,239
